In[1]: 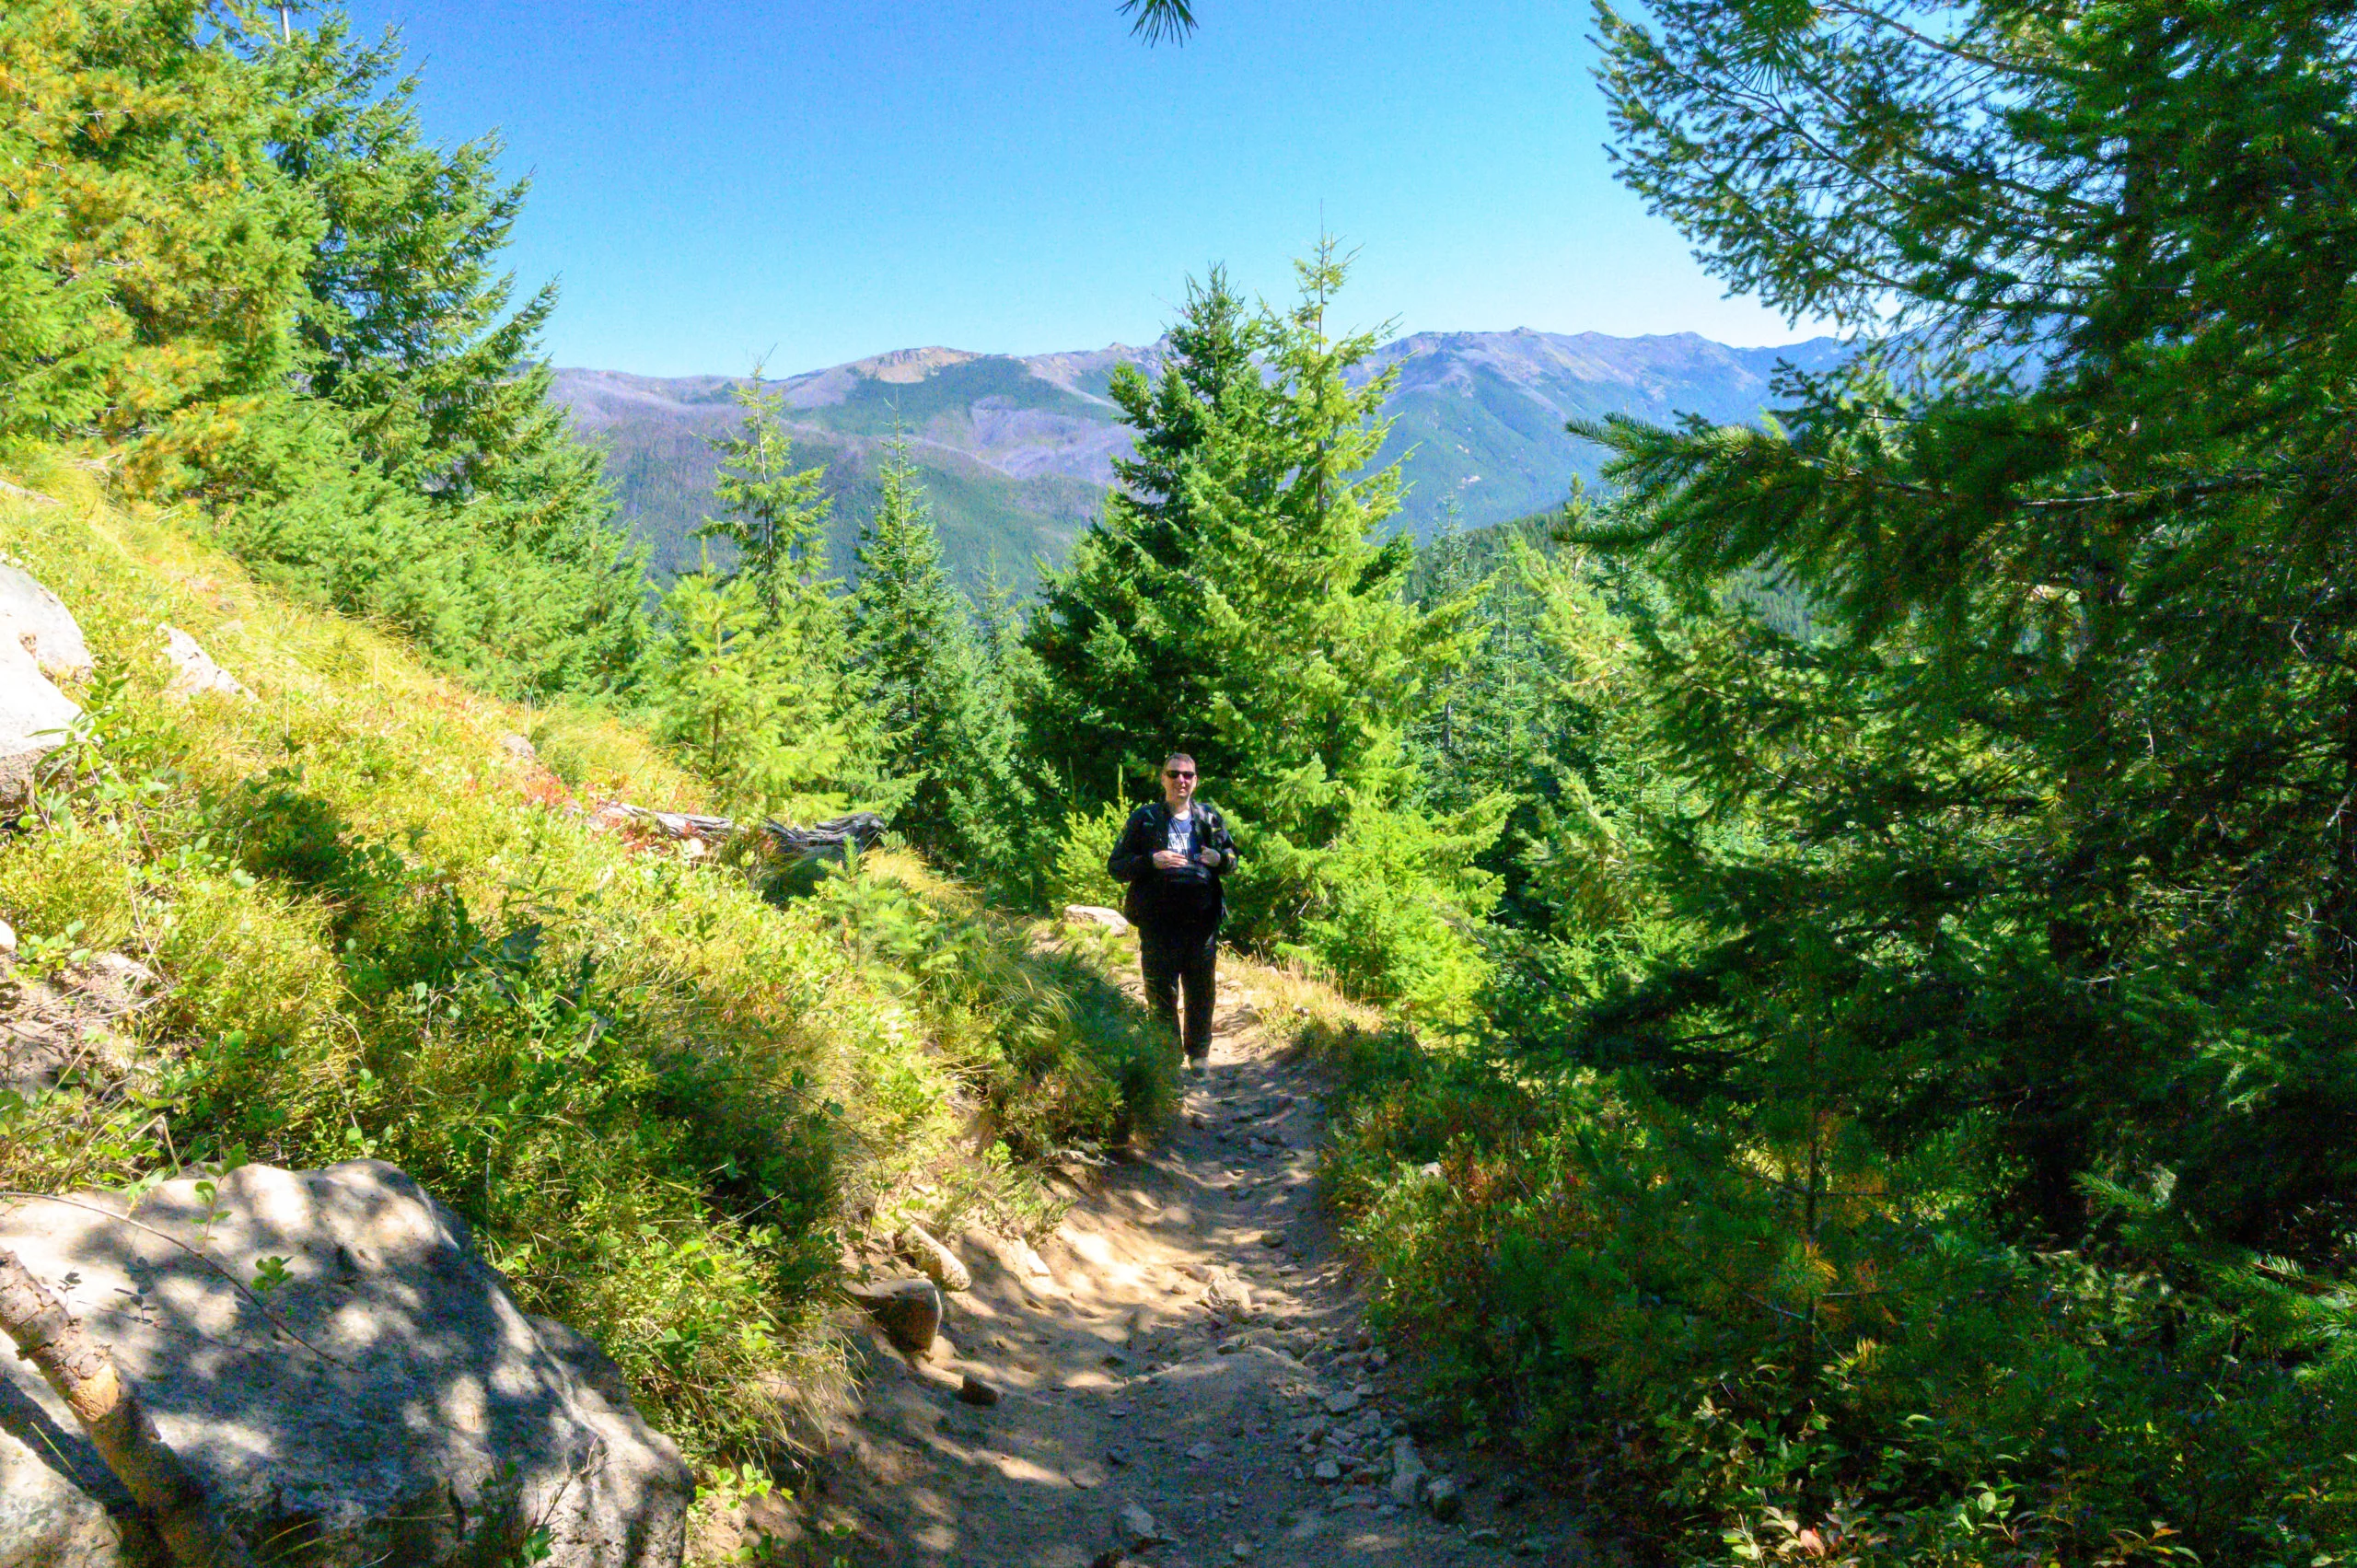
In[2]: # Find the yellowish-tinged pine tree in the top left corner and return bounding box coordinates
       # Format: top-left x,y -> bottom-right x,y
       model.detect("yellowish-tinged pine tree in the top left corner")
0,0 -> 319,493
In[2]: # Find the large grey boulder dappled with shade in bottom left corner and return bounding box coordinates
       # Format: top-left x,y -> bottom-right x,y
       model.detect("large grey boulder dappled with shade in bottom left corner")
0,1160 -> 693,1568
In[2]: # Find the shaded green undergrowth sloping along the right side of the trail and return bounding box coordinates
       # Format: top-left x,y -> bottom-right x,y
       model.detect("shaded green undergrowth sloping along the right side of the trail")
1301,1016 -> 2357,1568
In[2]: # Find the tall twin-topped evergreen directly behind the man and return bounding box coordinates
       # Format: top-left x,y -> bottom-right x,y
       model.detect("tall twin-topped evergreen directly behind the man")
1026,243 -> 1504,1021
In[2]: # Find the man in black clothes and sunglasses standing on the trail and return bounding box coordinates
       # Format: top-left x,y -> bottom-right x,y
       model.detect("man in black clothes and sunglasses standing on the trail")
1106,752 -> 1235,1073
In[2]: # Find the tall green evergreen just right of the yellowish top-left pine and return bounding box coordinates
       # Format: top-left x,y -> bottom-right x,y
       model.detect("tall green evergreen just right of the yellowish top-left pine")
224,14 -> 644,695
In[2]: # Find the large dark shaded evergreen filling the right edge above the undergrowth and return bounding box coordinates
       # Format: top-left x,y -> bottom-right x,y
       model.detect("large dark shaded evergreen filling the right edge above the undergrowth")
1582,0 -> 2357,1252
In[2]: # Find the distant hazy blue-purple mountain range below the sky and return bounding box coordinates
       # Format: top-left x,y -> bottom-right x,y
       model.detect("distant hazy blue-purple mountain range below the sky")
556,328 -> 1845,589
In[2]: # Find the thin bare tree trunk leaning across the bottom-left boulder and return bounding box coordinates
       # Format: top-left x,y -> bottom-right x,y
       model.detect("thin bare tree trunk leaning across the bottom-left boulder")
0,1248 -> 252,1568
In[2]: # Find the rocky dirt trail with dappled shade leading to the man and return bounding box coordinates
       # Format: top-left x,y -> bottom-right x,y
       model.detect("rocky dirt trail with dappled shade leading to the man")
808,964 -> 1591,1568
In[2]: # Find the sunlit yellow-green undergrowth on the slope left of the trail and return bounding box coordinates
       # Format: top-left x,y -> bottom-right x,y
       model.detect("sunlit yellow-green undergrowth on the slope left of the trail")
0,464 -> 1171,1459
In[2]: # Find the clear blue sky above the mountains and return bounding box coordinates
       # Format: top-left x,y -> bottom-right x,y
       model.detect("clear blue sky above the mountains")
322,0 -> 1810,375
